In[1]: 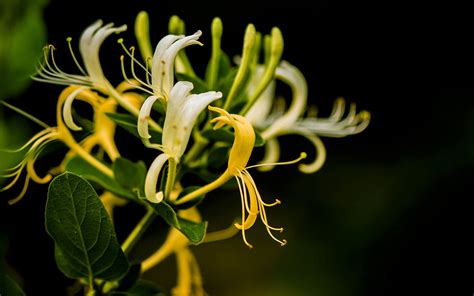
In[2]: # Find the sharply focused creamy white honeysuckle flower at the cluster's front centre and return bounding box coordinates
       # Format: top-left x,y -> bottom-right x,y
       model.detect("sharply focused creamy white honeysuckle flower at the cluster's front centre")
138,81 -> 222,203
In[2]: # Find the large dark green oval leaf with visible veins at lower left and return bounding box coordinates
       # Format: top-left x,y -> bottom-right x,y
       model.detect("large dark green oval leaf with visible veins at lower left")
45,172 -> 129,283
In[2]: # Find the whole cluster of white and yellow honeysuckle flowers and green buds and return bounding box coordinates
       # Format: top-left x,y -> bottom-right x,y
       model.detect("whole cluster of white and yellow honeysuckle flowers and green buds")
2,12 -> 370,295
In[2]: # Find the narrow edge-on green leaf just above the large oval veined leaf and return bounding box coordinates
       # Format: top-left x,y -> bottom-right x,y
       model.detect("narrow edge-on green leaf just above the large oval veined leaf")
66,156 -> 136,200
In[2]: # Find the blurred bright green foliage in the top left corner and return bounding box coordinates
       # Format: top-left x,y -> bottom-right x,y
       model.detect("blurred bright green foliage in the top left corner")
0,0 -> 47,99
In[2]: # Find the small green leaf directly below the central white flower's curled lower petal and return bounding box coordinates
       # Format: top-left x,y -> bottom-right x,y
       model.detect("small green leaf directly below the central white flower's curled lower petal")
150,201 -> 207,245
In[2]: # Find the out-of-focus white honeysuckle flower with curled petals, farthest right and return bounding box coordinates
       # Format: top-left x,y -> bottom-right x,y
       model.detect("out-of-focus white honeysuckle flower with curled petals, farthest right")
246,61 -> 370,173
